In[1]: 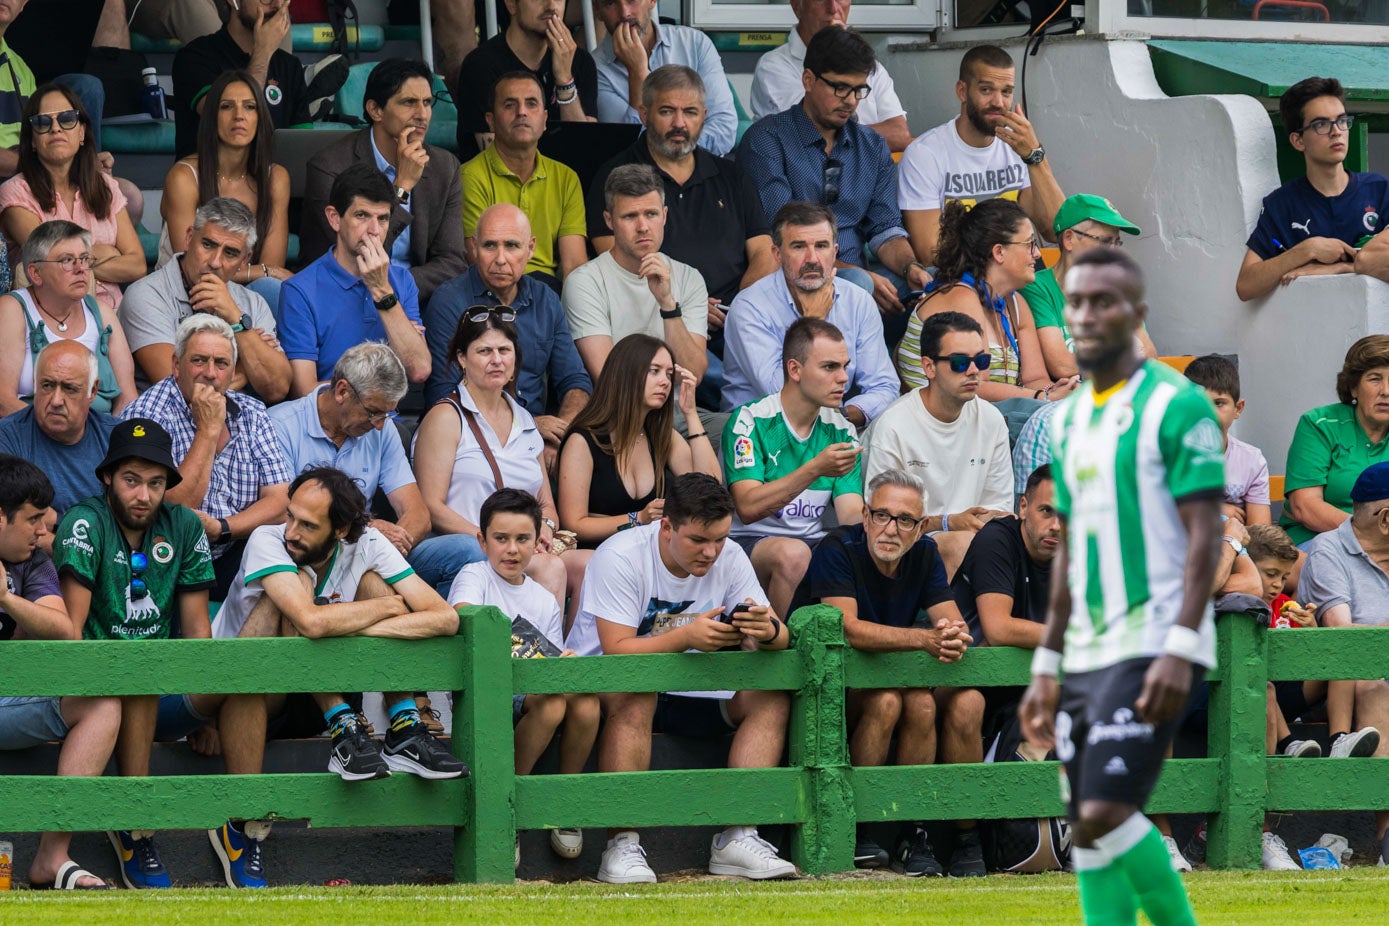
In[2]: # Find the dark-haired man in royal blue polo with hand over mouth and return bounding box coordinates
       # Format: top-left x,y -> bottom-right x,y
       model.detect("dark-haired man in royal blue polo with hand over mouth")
279,162 -> 429,397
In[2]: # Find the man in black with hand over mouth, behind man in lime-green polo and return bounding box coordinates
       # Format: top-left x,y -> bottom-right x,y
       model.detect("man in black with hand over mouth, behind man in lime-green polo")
456,0 -> 599,162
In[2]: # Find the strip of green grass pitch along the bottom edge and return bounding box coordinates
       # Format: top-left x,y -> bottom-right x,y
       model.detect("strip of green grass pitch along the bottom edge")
0,868 -> 1389,926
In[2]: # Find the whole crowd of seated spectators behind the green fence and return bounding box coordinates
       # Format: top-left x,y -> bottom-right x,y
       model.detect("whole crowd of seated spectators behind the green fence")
0,0 -> 1389,889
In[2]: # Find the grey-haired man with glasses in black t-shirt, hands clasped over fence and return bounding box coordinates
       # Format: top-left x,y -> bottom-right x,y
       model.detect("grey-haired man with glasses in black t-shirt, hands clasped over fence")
792,469 -> 985,877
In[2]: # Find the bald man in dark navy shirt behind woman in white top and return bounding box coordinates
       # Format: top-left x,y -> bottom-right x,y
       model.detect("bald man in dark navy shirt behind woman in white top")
424,203 -> 593,466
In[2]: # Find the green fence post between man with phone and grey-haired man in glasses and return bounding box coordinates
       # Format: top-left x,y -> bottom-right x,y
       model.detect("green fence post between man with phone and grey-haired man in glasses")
790,605 -> 854,875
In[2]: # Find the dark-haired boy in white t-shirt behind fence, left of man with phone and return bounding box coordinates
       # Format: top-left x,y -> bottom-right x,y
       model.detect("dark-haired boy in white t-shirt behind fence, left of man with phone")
449,489 -> 600,858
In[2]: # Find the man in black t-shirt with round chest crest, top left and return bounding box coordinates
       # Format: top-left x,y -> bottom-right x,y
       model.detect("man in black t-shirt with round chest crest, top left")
174,0 -> 310,157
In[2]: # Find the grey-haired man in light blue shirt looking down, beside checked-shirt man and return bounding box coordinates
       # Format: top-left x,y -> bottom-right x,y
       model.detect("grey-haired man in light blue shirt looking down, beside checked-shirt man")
269,342 -> 429,557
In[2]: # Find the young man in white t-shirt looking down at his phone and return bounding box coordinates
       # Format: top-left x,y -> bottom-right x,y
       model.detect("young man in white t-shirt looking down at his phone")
568,473 -> 796,884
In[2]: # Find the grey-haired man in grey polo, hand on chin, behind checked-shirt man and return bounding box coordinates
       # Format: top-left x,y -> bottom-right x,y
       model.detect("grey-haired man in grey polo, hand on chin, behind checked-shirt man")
121,196 -> 290,404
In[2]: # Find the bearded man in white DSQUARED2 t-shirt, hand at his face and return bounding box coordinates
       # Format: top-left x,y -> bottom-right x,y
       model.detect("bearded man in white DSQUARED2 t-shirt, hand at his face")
897,44 -> 1065,264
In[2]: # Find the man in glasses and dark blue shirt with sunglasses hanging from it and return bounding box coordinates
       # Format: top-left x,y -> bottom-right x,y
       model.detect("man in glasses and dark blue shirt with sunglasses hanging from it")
738,25 -> 931,329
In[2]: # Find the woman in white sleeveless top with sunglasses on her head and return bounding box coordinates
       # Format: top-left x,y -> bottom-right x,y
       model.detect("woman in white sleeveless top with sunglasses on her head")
410,305 -> 564,608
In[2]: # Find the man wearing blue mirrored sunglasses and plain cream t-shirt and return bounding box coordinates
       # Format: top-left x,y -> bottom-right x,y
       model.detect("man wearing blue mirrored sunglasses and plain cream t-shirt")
864,312 -> 1013,576
